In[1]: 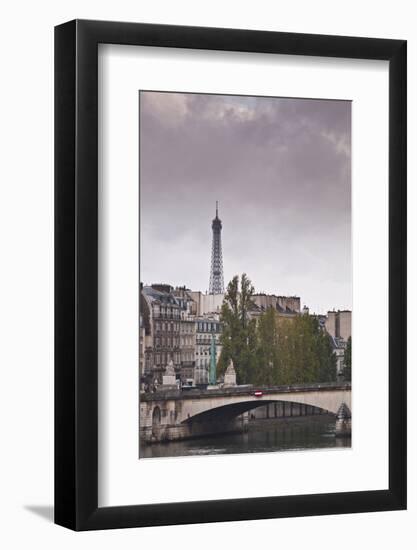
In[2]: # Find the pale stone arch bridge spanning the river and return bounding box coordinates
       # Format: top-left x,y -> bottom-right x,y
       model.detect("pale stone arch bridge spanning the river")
139,382 -> 351,443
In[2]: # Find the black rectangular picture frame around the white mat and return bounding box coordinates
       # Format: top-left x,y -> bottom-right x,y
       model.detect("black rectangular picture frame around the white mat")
55,20 -> 407,530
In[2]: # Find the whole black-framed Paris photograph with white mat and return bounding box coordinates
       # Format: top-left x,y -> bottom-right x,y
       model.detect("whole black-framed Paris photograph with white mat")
55,20 -> 406,530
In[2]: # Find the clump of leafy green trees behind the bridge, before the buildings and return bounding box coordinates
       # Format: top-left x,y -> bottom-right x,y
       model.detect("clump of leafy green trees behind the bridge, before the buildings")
219,273 -> 336,386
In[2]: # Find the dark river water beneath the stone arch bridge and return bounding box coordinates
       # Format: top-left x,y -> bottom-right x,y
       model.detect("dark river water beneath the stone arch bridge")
141,415 -> 351,458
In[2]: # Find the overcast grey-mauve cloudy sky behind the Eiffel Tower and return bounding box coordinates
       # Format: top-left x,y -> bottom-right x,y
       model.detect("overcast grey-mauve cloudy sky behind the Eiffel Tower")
140,92 -> 352,313
